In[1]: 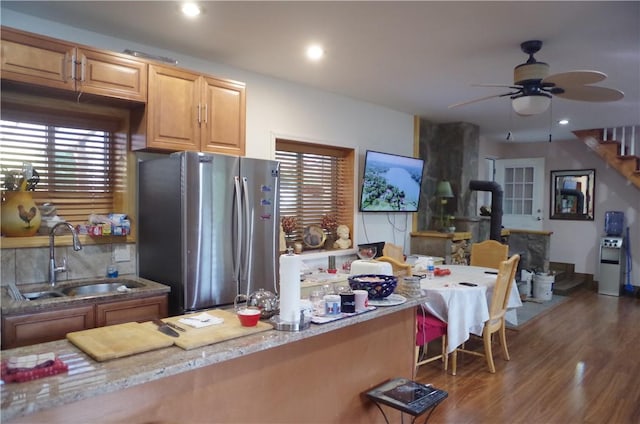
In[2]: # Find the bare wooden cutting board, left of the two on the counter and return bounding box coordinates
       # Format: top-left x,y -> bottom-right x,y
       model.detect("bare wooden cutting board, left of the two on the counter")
67,322 -> 173,361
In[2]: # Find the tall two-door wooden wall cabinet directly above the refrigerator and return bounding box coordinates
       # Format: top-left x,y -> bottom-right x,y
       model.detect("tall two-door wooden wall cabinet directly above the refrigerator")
132,64 -> 246,156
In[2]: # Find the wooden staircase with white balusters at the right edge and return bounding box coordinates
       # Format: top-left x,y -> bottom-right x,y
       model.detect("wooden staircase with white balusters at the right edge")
573,125 -> 640,189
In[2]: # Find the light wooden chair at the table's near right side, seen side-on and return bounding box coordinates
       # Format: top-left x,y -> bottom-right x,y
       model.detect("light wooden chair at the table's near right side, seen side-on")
451,254 -> 520,375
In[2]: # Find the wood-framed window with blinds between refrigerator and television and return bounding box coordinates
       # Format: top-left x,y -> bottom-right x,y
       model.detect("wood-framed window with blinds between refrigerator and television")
276,139 -> 354,240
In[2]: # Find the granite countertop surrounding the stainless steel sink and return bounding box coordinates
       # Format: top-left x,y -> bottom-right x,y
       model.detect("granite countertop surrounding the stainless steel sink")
0,275 -> 171,315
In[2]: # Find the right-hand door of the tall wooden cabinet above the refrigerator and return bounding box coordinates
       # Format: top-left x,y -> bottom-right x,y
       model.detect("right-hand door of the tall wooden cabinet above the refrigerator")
200,77 -> 246,156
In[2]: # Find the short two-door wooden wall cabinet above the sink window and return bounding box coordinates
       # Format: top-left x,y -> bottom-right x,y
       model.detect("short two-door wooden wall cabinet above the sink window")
1,27 -> 147,102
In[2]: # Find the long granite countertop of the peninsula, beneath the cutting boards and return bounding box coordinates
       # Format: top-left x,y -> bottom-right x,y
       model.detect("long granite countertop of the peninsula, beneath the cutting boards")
0,297 -> 426,421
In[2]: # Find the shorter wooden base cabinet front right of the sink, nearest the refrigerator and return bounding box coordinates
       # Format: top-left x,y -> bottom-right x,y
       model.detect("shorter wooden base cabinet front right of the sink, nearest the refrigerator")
96,294 -> 168,327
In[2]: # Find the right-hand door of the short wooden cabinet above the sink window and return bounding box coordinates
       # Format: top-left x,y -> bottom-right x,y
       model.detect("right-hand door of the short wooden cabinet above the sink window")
76,48 -> 147,102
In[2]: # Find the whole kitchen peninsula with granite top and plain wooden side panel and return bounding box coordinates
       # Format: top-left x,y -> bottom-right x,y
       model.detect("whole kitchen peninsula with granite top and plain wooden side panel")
1,297 -> 425,423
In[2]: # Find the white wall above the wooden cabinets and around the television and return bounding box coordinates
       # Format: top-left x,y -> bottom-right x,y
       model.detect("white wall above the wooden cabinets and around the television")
2,9 -> 413,252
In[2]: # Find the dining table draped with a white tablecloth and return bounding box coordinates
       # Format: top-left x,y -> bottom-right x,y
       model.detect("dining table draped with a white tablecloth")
420,265 -> 522,353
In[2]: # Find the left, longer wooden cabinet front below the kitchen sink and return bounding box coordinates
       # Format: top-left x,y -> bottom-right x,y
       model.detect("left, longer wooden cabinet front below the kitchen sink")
2,305 -> 95,349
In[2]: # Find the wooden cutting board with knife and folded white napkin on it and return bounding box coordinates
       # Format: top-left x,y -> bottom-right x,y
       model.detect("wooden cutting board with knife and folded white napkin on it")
142,309 -> 273,350
